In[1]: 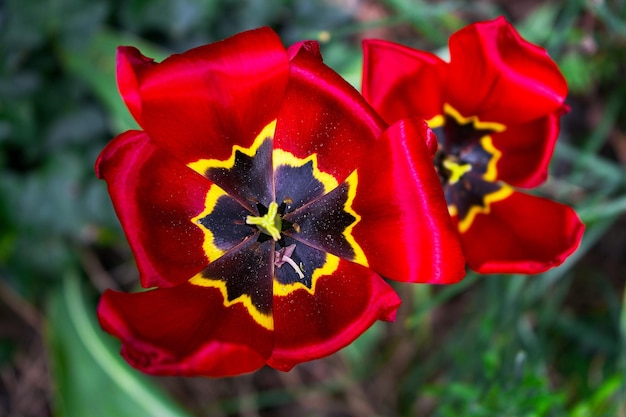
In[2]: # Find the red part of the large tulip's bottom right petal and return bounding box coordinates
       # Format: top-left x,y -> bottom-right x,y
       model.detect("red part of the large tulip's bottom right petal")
267,260 -> 400,371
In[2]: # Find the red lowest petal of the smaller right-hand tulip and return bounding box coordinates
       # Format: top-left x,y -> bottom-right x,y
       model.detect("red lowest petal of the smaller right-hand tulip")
461,192 -> 584,274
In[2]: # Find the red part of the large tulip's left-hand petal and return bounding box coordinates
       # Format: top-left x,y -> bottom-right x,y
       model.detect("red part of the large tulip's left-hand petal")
96,131 -> 211,287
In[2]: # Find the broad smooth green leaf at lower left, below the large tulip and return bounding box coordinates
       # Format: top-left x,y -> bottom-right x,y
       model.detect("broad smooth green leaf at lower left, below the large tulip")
46,274 -> 190,417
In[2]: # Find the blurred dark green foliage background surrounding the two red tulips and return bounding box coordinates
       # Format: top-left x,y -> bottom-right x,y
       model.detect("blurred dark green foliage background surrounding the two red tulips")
0,0 -> 626,417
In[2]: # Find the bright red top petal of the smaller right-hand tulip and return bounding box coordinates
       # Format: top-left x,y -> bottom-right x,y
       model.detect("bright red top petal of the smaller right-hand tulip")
447,17 -> 567,126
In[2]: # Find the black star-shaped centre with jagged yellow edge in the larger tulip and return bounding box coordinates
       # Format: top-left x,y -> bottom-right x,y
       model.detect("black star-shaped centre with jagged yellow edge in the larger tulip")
188,121 -> 367,330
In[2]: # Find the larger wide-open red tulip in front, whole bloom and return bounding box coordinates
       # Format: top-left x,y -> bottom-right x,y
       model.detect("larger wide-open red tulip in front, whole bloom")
96,28 -> 465,376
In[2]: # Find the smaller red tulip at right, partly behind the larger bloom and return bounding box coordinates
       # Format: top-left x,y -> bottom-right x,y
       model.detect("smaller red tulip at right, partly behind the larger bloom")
363,18 -> 584,273
